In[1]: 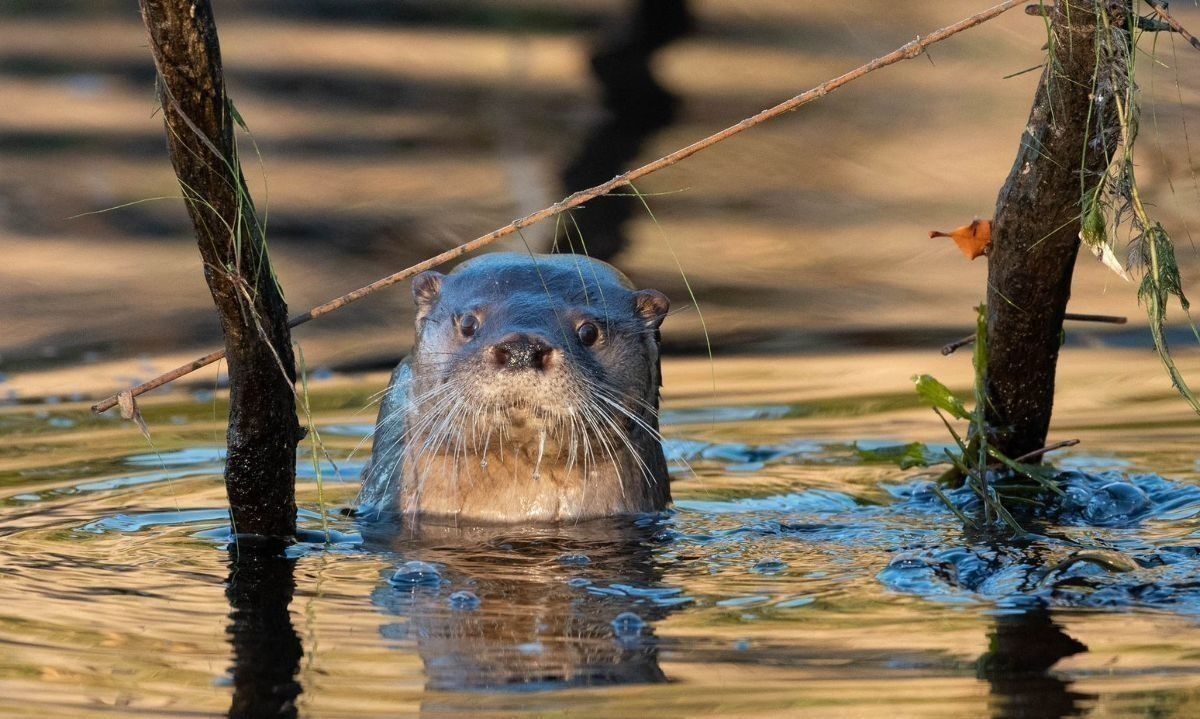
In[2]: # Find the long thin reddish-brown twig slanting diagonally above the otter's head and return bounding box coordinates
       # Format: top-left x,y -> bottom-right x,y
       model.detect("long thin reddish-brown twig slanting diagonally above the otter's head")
91,0 -> 1026,412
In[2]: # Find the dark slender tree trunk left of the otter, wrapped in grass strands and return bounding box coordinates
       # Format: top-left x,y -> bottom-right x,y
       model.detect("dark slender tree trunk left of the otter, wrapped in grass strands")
140,0 -> 302,537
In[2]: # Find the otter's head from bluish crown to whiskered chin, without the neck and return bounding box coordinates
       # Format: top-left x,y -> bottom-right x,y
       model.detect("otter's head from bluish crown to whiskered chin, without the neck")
413,254 -> 670,443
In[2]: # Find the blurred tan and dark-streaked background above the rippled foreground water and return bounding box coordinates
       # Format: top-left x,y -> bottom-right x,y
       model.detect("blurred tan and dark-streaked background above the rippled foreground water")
0,0 -> 1200,401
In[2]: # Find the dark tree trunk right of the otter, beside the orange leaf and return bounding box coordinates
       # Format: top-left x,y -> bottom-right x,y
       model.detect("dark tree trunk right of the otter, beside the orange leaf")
986,0 -> 1129,457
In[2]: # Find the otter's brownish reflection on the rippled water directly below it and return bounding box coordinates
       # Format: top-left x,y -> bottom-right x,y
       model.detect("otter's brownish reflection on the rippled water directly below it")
364,520 -> 688,696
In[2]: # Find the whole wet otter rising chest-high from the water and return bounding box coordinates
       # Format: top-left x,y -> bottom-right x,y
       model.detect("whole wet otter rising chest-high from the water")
359,253 -> 671,523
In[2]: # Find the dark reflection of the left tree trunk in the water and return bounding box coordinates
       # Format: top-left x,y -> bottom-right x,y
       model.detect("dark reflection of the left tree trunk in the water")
226,541 -> 304,719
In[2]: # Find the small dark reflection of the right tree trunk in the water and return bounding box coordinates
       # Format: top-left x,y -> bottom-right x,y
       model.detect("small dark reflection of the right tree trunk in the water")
977,606 -> 1096,719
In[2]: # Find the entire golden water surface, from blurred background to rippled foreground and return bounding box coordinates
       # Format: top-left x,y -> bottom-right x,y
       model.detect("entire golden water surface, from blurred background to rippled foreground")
0,0 -> 1200,719
